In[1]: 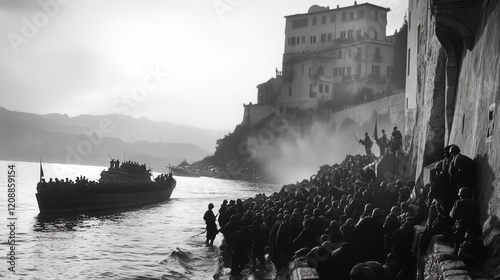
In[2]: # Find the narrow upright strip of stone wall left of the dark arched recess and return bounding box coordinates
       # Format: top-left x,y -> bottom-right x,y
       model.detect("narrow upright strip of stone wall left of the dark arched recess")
406,5 -> 446,180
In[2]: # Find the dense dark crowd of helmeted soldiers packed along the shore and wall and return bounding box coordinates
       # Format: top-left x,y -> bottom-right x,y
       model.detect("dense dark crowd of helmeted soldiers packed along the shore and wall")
205,146 -> 480,279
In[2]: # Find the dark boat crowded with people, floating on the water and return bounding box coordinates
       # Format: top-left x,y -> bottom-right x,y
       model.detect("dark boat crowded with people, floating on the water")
36,161 -> 176,214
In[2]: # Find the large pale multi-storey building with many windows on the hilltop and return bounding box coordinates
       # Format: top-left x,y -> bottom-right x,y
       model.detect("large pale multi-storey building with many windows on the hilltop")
243,1 -> 402,125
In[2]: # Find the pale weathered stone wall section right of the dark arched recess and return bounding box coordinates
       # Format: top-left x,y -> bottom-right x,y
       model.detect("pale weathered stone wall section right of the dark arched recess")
450,1 -> 500,275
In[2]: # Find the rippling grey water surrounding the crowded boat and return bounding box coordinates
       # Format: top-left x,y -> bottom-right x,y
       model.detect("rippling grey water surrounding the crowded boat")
0,161 -> 280,279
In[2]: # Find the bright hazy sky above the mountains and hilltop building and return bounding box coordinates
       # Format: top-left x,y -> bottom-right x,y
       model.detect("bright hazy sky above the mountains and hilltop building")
0,0 -> 408,130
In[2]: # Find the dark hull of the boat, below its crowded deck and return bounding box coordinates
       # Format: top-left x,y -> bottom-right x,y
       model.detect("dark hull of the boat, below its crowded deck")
36,181 -> 175,214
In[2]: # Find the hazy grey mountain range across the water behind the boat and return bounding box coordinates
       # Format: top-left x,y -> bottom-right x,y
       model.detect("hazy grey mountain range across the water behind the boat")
0,107 -> 218,171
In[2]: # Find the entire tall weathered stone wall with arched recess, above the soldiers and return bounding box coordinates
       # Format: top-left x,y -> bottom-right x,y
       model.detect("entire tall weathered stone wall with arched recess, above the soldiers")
407,1 -> 500,276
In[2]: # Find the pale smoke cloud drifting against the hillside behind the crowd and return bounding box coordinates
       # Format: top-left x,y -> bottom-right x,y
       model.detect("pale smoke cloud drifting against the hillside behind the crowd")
248,112 -> 395,184
